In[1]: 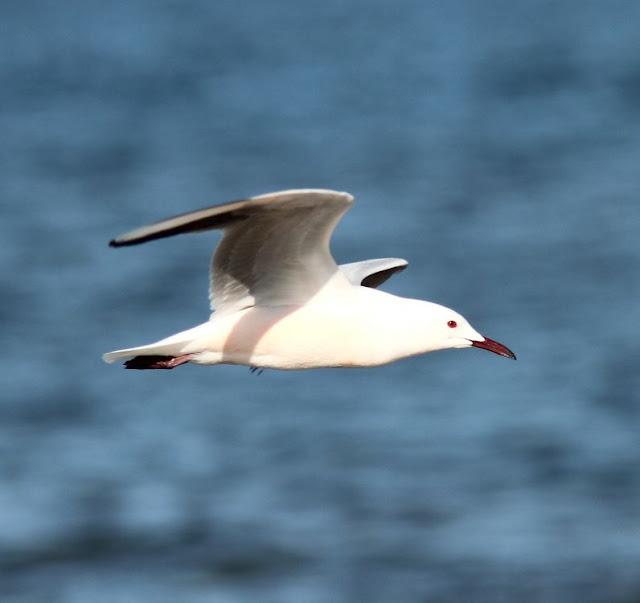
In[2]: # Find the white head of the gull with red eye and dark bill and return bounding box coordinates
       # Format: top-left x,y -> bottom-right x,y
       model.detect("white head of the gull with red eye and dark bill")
426,302 -> 516,360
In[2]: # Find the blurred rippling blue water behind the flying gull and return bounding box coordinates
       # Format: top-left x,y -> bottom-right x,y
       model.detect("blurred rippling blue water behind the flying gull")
0,0 -> 640,603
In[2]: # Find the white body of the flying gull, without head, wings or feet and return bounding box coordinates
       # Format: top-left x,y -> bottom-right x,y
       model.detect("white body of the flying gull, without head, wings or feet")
109,286 -> 470,369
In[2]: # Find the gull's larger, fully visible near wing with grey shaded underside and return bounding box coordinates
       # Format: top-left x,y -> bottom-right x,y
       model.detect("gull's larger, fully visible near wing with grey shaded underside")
110,189 -> 353,314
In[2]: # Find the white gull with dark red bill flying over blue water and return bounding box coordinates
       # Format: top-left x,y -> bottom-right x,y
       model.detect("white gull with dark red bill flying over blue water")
103,189 -> 515,369
